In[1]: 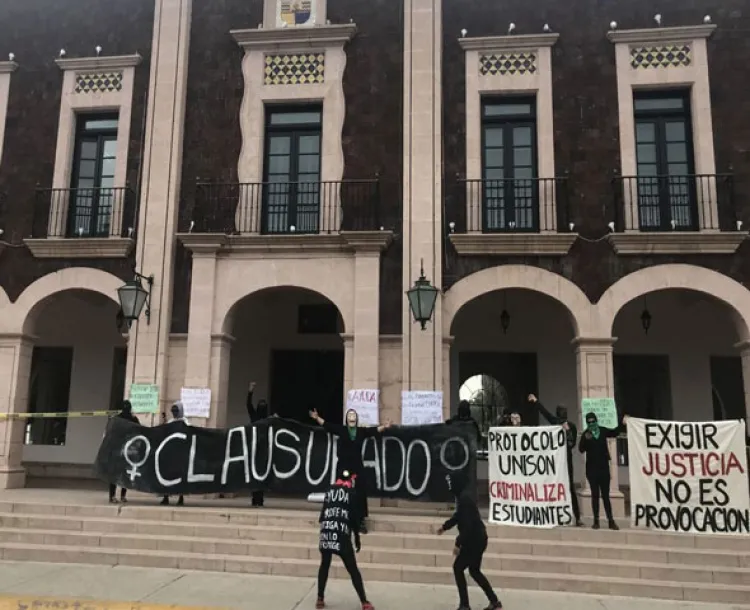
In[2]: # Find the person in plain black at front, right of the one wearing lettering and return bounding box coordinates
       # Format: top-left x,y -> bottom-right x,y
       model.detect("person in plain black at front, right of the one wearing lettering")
437,472 -> 503,610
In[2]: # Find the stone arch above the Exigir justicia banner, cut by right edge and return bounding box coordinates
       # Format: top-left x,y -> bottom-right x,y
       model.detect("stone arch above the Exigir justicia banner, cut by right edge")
595,264 -> 750,341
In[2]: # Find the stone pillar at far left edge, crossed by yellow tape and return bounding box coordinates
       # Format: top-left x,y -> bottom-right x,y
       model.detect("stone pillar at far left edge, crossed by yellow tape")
0,335 -> 34,489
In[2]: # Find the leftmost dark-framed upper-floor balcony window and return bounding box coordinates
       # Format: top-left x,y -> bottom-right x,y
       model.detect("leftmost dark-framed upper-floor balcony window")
68,114 -> 118,237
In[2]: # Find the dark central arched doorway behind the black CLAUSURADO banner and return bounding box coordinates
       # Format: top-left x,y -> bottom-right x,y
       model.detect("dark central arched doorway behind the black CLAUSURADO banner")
225,286 -> 345,425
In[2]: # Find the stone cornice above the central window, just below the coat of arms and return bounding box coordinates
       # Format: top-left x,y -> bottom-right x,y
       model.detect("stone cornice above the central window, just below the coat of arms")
229,23 -> 357,51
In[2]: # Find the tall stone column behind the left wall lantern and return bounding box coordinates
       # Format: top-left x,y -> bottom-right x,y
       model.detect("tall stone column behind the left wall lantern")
127,0 -> 192,414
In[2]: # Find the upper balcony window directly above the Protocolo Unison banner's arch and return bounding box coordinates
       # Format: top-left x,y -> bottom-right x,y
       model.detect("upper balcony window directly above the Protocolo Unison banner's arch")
482,98 -> 539,232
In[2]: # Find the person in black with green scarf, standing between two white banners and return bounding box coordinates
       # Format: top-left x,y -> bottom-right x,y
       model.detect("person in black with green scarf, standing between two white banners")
578,413 -> 628,530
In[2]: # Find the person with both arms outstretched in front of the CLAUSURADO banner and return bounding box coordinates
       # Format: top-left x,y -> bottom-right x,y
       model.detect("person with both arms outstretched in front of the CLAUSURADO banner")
310,409 -> 391,534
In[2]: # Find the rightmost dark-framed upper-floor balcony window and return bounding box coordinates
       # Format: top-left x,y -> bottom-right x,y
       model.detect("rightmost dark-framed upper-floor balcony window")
633,91 -> 698,231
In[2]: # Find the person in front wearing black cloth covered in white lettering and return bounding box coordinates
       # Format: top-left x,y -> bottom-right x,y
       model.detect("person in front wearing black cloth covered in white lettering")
315,470 -> 375,610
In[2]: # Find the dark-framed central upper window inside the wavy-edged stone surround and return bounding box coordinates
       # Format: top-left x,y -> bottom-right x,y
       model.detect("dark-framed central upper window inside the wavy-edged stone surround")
262,106 -> 323,233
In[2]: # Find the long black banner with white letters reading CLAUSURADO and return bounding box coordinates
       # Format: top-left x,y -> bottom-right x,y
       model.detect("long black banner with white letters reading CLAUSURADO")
95,417 -> 476,502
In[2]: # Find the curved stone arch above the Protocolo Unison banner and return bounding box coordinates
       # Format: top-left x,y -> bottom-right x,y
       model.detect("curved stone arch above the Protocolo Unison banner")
443,265 -> 597,337
